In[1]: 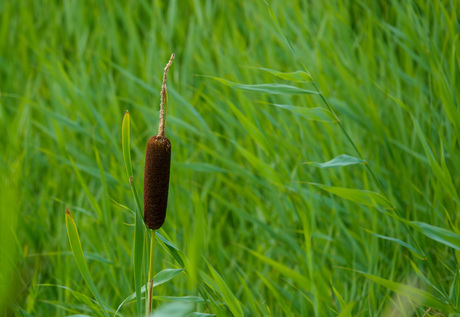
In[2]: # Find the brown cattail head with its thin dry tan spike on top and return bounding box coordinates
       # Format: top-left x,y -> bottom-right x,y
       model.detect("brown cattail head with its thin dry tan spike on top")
144,54 -> 174,229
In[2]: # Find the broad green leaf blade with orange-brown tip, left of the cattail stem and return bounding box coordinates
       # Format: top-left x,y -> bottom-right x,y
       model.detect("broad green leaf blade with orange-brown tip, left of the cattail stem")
65,207 -> 108,317
